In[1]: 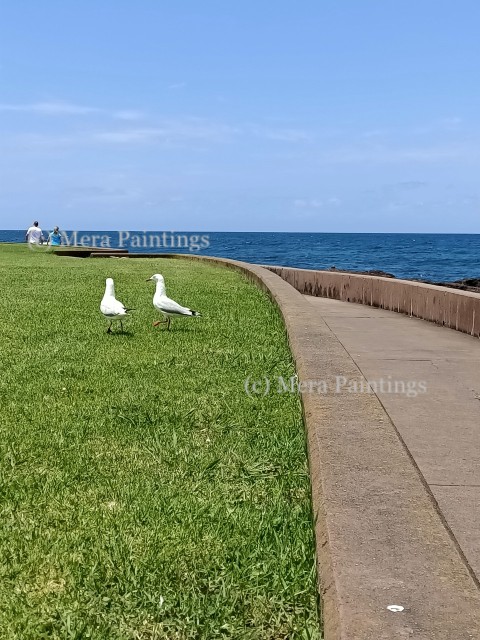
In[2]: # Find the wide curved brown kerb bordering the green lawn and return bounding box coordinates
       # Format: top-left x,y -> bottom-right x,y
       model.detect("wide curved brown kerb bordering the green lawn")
142,254 -> 480,640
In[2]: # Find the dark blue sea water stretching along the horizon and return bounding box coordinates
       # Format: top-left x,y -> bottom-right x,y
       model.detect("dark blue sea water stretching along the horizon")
0,231 -> 480,281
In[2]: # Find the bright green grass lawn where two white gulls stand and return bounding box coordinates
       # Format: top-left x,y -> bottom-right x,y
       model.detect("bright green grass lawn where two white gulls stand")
0,245 -> 319,640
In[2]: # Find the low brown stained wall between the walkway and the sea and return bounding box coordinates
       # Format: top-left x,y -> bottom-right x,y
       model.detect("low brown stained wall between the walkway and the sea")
266,266 -> 480,337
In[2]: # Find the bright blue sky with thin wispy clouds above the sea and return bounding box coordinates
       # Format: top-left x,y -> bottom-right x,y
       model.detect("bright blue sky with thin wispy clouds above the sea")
0,0 -> 480,233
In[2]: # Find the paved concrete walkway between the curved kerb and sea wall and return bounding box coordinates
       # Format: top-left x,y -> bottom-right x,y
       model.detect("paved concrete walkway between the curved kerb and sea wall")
305,296 -> 480,584
